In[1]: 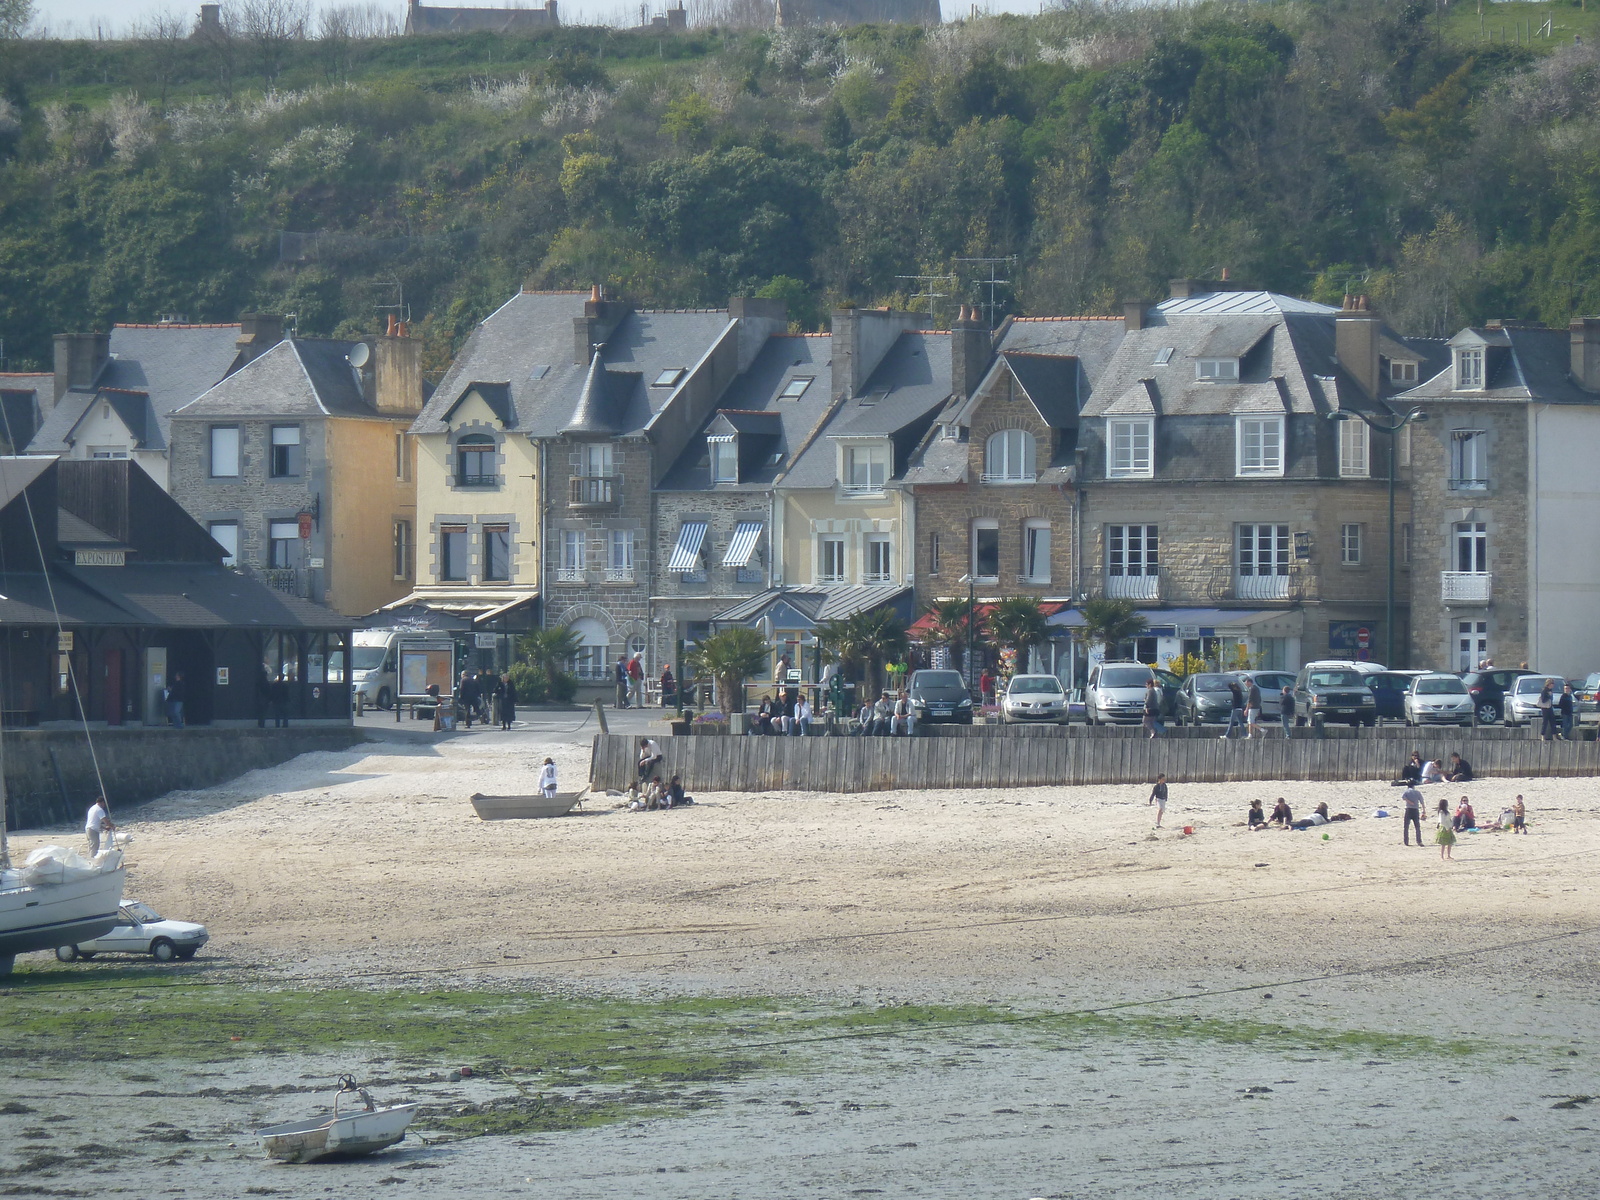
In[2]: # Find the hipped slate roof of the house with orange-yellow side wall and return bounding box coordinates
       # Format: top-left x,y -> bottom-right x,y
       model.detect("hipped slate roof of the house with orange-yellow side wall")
173,338 -> 382,419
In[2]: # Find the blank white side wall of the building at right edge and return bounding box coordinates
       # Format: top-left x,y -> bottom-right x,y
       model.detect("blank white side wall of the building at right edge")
1528,405 -> 1600,678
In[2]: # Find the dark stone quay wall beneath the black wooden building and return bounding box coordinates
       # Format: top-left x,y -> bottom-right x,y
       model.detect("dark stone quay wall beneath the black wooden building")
5,725 -> 366,829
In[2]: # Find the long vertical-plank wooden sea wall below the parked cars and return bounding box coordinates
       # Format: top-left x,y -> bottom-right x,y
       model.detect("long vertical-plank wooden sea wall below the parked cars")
590,730 -> 1600,794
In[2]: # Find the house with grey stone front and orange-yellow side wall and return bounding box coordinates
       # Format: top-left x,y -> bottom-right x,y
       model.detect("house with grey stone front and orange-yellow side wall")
170,336 -> 422,616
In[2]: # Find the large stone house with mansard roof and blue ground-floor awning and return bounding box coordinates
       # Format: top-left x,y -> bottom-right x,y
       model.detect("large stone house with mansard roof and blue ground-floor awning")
1074,280 -> 1440,669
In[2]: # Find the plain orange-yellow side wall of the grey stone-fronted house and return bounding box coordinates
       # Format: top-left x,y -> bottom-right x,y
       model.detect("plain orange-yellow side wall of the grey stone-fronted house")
326,418 -> 416,616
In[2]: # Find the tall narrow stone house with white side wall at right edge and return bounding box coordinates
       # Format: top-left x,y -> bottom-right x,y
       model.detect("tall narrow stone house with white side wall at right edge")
1397,318 -> 1600,677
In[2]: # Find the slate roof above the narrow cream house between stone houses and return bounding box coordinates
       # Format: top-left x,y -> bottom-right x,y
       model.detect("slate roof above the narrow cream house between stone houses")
782,330 -> 950,488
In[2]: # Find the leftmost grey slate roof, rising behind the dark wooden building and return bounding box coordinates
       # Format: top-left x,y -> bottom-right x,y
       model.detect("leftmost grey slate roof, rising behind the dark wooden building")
29,325 -> 240,454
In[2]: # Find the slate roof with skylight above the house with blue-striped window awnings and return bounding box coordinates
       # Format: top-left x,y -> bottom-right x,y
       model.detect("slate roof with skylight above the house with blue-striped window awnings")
659,333 -> 834,491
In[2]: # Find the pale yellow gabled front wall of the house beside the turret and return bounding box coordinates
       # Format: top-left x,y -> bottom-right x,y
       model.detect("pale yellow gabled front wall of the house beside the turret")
411,394 -> 544,587
